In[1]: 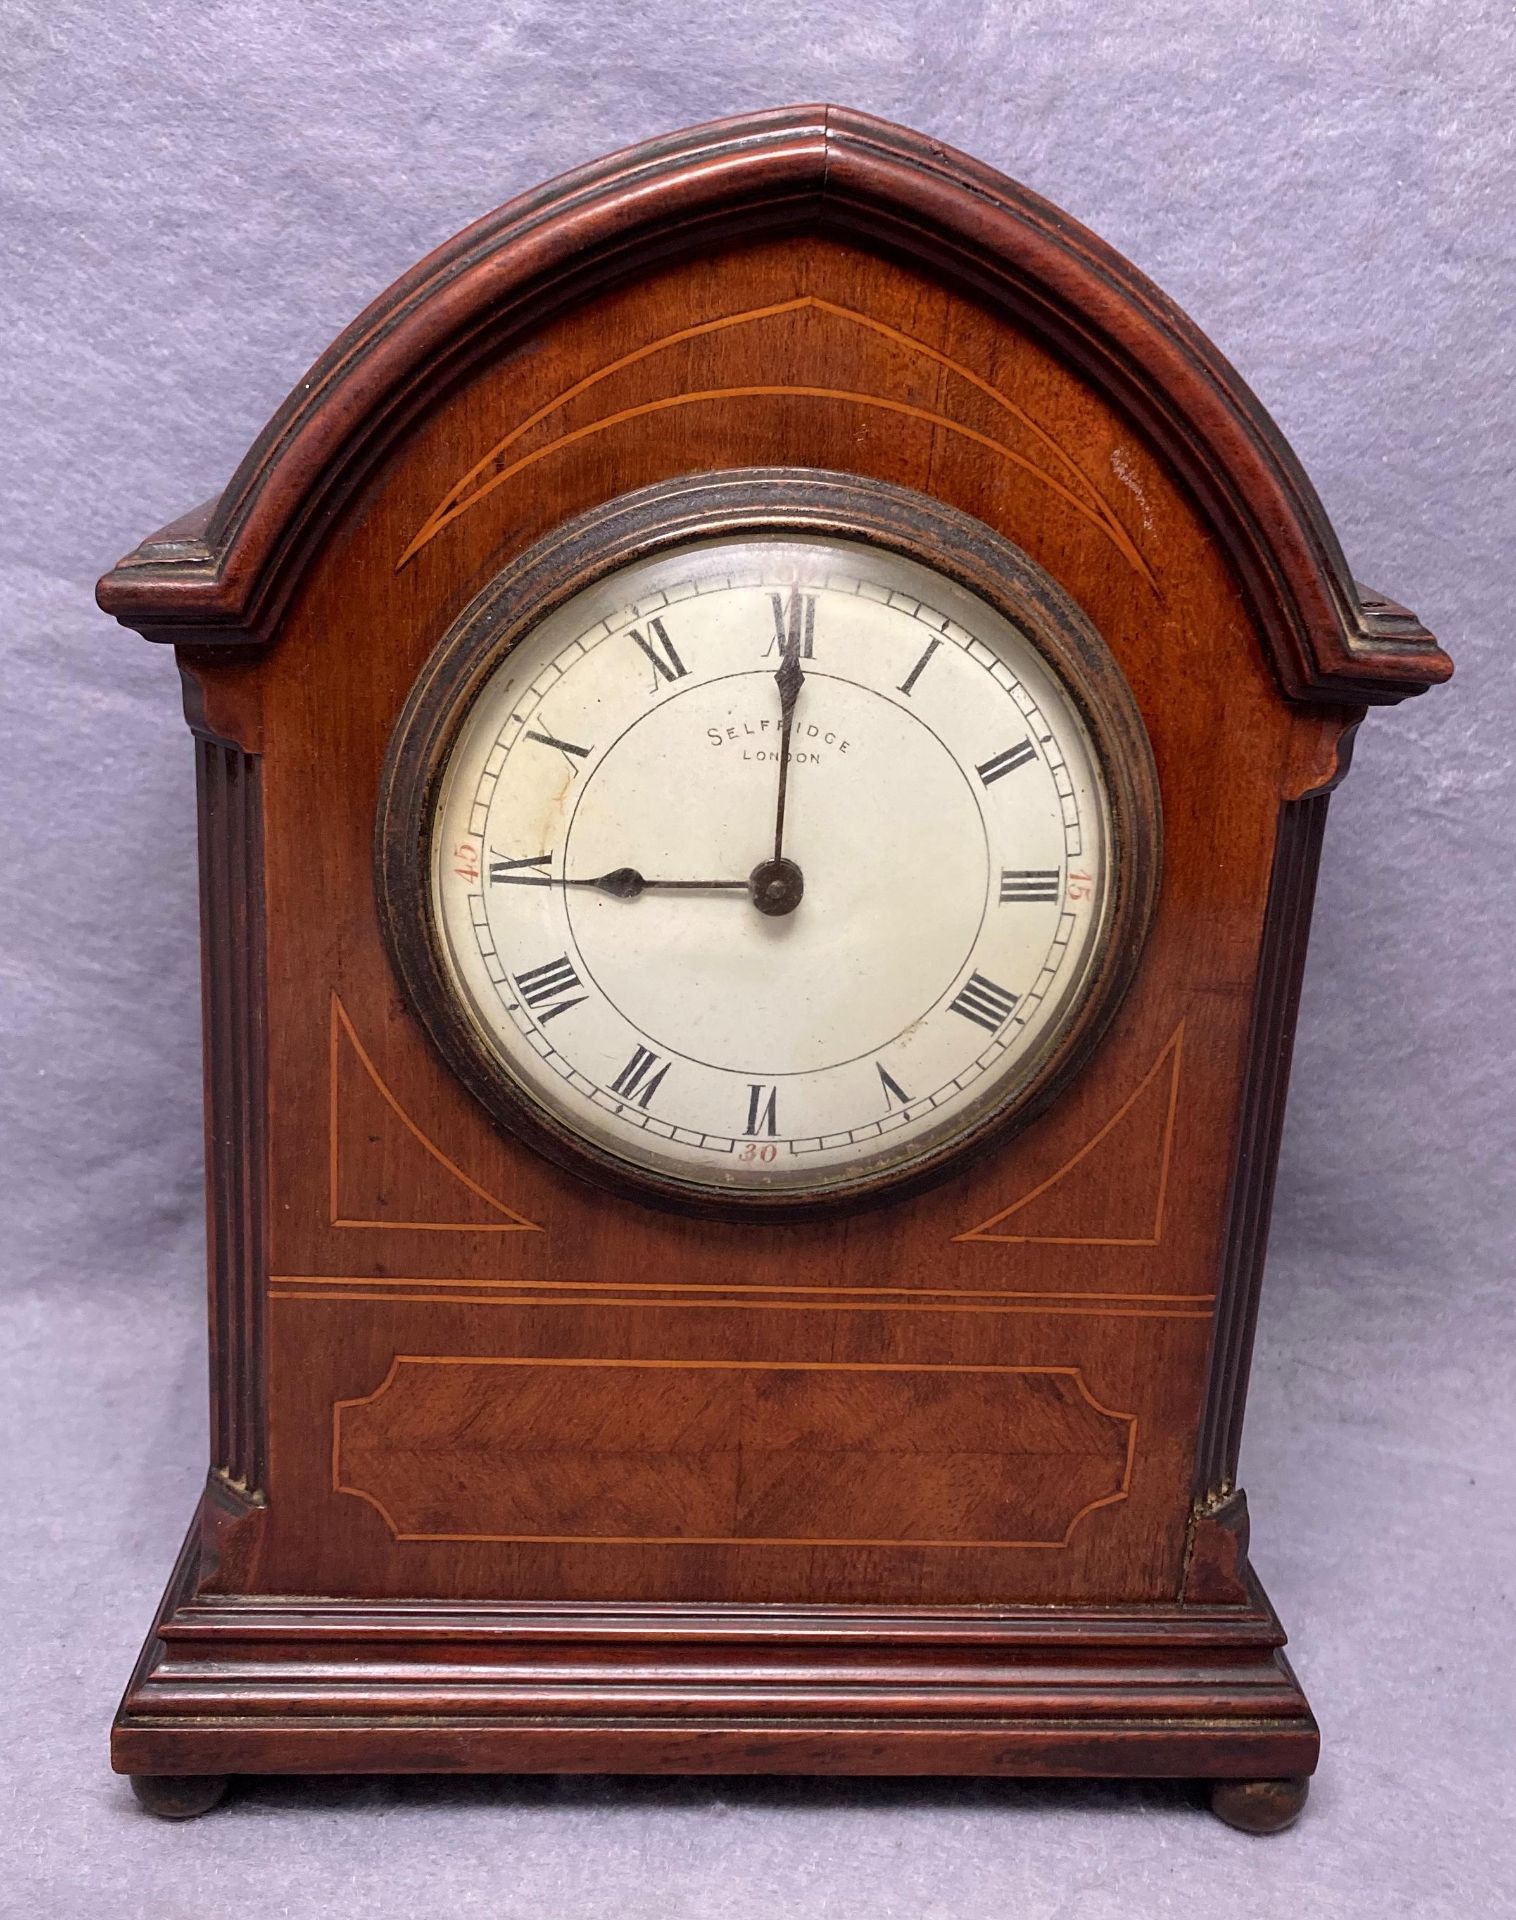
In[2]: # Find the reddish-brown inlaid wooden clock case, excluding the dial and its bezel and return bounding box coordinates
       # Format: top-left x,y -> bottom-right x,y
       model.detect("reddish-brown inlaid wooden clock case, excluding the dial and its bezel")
100,108 -> 1451,1830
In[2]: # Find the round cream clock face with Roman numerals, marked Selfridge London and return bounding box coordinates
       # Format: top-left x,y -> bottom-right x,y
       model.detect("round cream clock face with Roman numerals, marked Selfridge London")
383,474 -> 1166,1206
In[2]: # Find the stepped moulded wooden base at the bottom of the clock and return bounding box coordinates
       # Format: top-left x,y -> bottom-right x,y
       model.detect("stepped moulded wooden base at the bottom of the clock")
111,1526 -> 1318,1789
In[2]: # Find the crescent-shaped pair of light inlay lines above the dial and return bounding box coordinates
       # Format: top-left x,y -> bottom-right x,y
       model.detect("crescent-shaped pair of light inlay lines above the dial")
395,294 -> 1153,586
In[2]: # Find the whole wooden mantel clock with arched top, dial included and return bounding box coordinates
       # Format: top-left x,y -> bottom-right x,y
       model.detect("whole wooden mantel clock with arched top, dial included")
100,108 -> 1449,1830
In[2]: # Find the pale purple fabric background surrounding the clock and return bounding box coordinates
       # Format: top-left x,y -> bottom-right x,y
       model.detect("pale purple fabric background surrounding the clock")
0,0 -> 1516,1920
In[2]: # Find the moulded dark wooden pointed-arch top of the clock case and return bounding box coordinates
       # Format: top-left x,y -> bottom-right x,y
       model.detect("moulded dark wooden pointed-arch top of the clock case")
98,106 -> 1453,705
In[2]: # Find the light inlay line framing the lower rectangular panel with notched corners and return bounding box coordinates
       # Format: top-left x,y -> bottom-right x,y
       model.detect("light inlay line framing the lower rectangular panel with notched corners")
332,1354 -> 1138,1551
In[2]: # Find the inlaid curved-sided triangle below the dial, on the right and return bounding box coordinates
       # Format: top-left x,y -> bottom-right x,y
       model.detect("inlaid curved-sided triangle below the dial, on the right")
954,1021 -> 1184,1246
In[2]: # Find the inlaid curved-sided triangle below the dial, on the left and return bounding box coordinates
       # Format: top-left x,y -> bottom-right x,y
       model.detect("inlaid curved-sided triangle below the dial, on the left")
330,993 -> 541,1233
